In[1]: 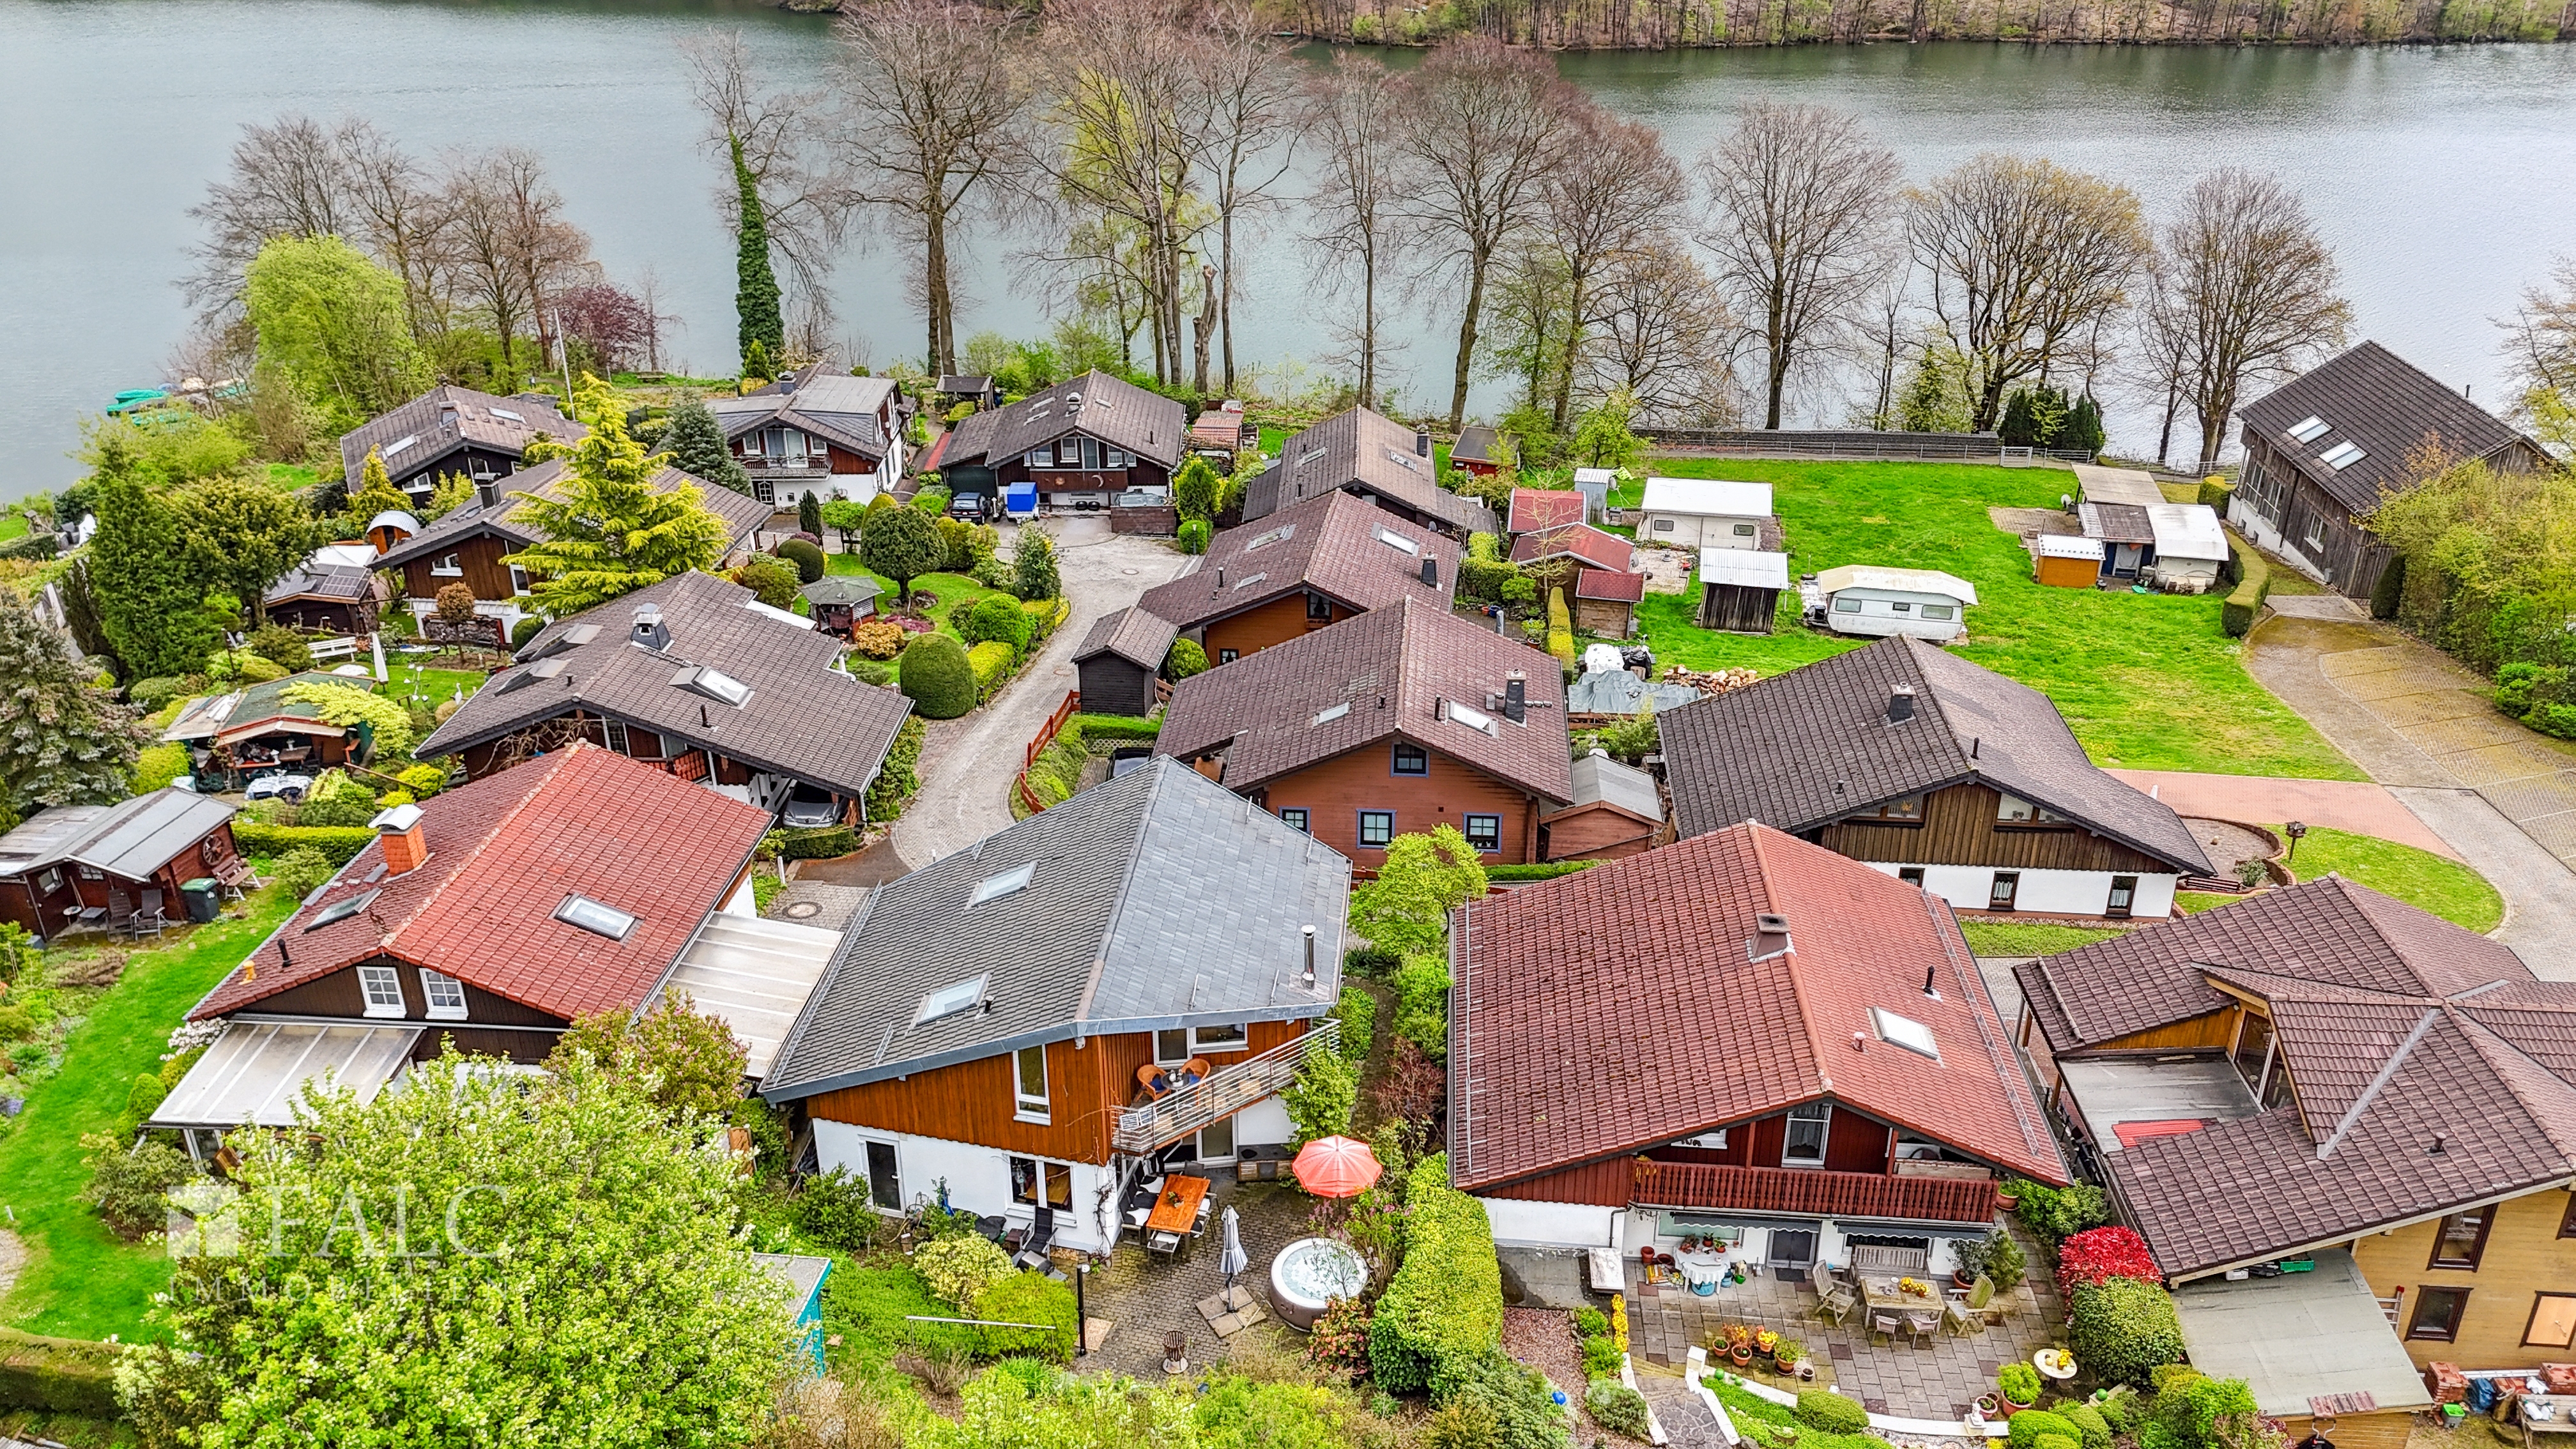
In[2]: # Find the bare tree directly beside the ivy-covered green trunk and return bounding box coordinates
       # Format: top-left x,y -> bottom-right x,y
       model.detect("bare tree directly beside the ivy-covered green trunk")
680,31 -> 850,353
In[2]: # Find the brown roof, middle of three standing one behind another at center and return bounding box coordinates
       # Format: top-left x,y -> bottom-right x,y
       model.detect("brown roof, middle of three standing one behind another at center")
1138,493 -> 1458,629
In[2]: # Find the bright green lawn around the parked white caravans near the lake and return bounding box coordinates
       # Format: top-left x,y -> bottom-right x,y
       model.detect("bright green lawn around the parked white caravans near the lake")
1638,459 -> 2365,779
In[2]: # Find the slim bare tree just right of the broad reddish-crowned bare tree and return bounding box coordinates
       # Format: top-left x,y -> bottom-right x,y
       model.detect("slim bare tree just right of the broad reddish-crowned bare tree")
1540,98 -> 1685,431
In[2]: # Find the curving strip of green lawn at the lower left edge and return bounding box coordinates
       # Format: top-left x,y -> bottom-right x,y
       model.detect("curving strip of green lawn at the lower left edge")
0,887 -> 294,1341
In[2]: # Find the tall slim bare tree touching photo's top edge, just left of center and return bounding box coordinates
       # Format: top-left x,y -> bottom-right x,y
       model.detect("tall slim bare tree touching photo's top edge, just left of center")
1198,0 -> 1301,392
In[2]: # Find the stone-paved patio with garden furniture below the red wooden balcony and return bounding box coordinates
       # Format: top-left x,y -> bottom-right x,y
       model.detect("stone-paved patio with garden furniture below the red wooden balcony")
1628,1227 -> 2066,1418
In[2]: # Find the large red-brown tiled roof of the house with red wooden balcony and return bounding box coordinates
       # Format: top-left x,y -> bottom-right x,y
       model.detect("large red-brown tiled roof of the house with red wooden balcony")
1450,825 -> 2066,1188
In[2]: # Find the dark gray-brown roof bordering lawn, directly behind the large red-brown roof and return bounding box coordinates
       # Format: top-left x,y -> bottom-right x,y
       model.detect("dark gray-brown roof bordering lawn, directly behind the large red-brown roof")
1659,634 -> 2210,874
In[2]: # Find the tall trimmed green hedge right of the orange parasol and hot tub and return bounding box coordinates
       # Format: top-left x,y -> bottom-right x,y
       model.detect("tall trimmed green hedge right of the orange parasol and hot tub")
1368,1153 -> 1502,1395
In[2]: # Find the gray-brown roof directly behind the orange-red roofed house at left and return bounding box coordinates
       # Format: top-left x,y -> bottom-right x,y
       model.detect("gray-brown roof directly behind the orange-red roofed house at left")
417,572 -> 912,797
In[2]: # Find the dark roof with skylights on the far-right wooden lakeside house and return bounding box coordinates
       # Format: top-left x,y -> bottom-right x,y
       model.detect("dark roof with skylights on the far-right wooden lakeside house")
2236,343 -> 2543,513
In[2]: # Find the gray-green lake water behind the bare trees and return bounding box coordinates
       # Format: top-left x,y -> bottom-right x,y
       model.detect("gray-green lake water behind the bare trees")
0,0 -> 2576,498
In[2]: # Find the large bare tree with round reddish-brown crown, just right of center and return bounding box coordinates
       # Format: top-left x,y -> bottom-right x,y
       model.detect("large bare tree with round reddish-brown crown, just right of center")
1401,36 -> 1568,428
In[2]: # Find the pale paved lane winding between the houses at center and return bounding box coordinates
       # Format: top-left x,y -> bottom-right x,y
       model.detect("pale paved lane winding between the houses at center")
894,516 -> 1190,869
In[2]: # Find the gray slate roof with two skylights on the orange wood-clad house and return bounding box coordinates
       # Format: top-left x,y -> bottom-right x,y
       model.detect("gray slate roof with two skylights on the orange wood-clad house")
760,760 -> 1350,1101
